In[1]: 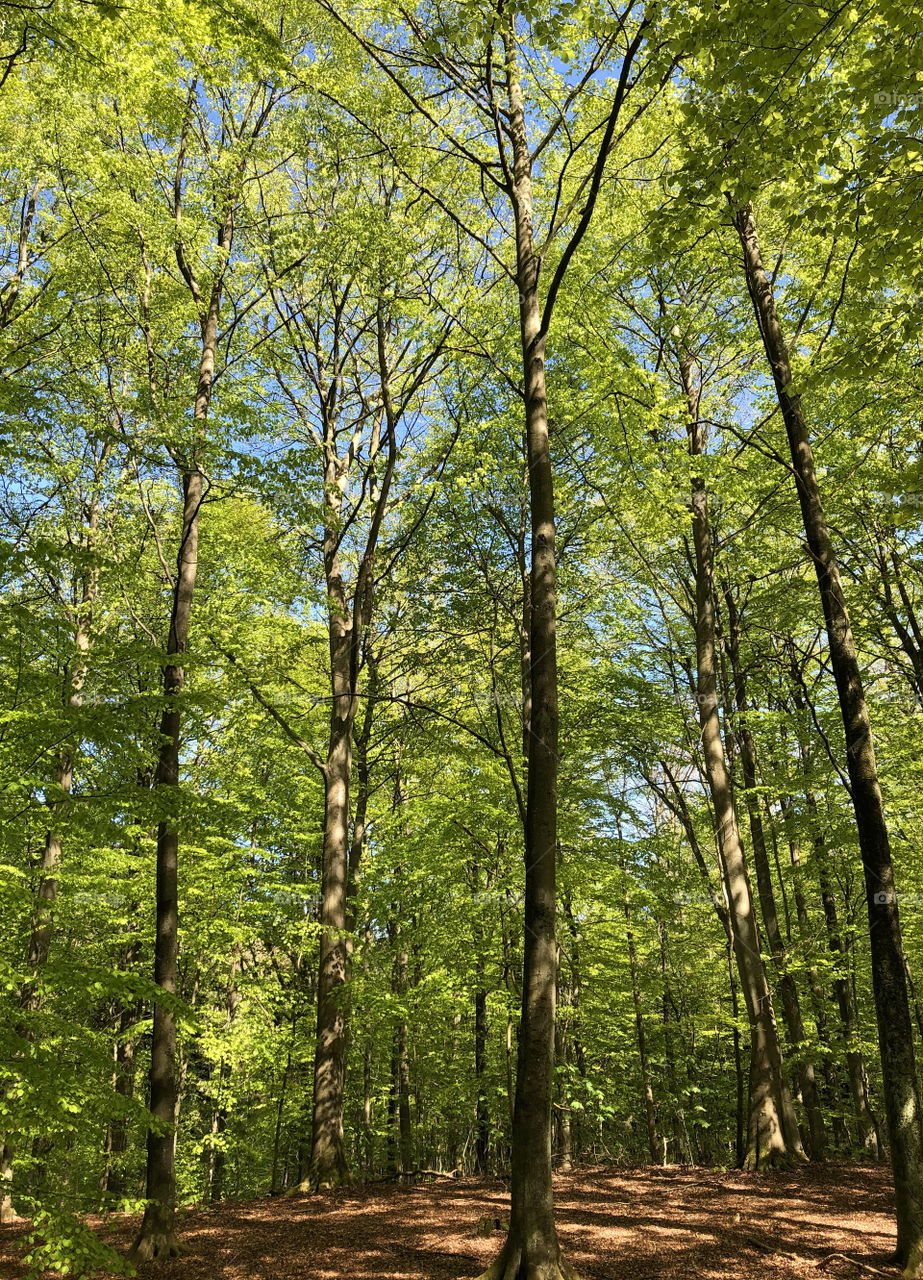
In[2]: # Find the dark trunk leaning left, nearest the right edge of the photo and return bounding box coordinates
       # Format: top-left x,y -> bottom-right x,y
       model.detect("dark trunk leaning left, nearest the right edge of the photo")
735,205 -> 923,1277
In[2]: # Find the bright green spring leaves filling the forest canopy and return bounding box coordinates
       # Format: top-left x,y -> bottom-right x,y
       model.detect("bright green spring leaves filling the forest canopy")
0,0 -> 923,1276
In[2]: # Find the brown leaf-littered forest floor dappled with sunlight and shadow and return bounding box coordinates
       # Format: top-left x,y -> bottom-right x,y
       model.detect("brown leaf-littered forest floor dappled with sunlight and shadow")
0,1165 -> 900,1280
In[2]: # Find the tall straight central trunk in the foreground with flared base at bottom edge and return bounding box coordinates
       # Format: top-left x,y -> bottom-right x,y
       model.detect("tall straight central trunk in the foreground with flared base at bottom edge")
485,31 -> 572,1280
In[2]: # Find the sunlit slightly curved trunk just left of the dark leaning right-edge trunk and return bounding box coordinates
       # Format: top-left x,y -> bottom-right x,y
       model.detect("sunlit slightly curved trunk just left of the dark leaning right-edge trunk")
677,325 -> 801,1169
